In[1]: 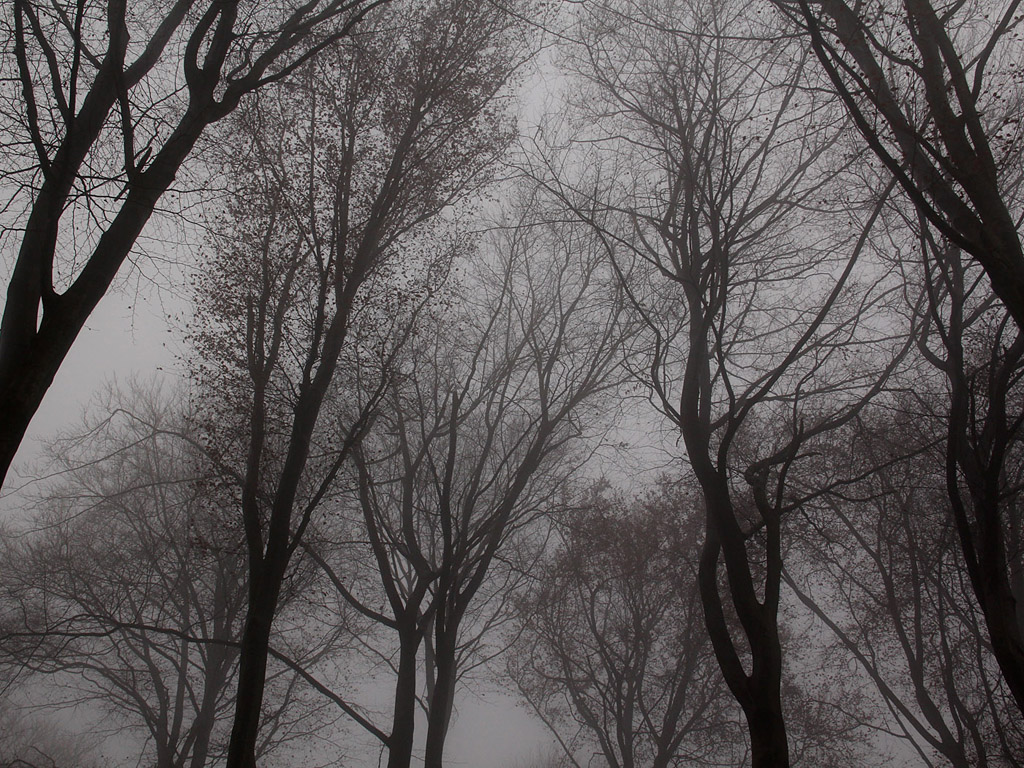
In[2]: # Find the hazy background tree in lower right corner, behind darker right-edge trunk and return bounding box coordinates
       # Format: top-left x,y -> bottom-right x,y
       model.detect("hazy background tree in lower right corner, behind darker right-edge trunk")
785,421 -> 1024,768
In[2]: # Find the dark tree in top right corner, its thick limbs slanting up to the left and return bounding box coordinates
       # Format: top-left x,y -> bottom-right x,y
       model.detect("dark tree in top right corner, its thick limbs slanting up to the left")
773,0 -> 1024,326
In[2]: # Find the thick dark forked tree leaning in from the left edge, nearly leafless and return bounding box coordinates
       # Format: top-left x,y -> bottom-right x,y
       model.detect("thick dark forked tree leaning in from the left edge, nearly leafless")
0,0 -> 384,477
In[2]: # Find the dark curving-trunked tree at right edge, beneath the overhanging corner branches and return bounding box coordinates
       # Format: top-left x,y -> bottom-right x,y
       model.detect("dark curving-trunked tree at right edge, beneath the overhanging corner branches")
919,233 -> 1024,712
